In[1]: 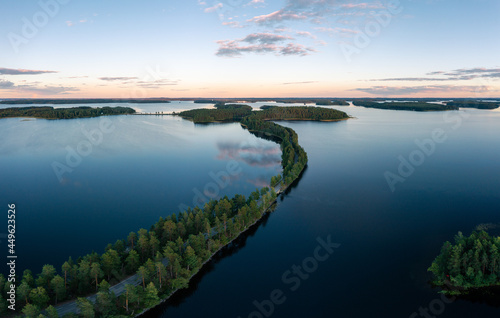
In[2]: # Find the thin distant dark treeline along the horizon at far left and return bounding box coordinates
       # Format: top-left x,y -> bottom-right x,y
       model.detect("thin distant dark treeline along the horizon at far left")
0,98 -> 170,104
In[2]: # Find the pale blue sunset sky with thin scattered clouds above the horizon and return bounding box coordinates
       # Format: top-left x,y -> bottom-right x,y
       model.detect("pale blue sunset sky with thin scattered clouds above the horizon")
0,0 -> 500,99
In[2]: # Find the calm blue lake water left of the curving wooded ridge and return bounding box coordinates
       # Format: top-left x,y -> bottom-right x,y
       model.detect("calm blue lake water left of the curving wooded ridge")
0,108 -> 281,273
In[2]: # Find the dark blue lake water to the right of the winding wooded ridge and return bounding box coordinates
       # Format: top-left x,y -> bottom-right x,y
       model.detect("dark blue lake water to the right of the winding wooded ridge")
150,107 -> 500,318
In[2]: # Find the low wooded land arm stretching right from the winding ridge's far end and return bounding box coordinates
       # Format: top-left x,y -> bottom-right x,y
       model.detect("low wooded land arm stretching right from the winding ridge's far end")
252,106 -> 349,120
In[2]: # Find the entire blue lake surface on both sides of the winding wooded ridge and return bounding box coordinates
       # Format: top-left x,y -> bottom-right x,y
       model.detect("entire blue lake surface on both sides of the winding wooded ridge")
0,104 -> 500,318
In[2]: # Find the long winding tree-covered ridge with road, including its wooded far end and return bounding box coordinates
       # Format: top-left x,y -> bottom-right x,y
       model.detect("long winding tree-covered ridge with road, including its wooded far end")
0,105 -> 340,318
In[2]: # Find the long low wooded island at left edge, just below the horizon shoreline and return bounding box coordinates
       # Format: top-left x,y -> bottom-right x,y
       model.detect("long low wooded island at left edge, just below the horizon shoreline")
0,106 -> 135,119
